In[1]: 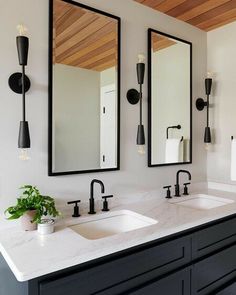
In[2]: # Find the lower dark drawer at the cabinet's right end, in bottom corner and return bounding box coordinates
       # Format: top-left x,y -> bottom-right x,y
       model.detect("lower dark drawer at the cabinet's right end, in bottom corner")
192,245 -> 236,295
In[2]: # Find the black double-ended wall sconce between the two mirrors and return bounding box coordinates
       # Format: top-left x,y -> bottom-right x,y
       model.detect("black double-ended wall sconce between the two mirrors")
126,54 -> 145,154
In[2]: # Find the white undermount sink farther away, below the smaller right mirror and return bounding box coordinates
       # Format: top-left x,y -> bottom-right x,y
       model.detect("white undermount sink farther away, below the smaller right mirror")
174,194 -> 234,210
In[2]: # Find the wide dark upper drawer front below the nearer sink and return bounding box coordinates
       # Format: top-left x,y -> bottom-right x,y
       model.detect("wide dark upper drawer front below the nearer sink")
39,237 -> 191,295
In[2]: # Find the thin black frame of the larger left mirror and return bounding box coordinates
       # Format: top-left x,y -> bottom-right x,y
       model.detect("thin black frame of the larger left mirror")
48,0 -> 121,176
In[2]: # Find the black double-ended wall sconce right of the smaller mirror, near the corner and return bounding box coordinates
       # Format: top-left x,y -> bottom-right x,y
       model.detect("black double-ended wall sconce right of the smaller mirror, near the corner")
196,77 -> 212,146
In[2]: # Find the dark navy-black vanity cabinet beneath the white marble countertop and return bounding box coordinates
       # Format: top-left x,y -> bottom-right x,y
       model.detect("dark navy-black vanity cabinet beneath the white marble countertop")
0,215 -> 236,295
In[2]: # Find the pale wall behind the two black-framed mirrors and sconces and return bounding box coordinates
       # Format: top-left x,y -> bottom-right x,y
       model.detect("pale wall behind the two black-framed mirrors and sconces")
0,0 -> 206,211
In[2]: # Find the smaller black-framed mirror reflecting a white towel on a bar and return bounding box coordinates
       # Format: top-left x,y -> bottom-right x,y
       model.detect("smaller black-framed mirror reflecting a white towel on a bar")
148,29 -> 192,167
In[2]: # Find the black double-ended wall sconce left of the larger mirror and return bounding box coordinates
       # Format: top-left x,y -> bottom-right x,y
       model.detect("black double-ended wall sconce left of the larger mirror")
8,25 -> 30,160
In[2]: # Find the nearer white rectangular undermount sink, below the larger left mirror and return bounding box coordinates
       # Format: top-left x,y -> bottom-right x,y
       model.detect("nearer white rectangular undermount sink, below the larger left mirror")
70,210 -> 158,240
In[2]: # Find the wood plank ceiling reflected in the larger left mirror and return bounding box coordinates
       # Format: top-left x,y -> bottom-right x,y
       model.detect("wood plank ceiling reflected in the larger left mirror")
53,0 -> 118,71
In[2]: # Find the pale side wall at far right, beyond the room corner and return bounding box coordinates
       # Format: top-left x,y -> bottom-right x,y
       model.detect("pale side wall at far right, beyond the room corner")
207,22 -> 236,184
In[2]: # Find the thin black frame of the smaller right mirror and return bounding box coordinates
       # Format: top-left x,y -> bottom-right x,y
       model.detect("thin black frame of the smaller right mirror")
148,28 -> 193,167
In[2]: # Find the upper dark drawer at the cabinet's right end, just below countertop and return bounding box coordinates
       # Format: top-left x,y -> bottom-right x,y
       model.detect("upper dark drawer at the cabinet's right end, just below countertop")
192,218 -> 236,259
